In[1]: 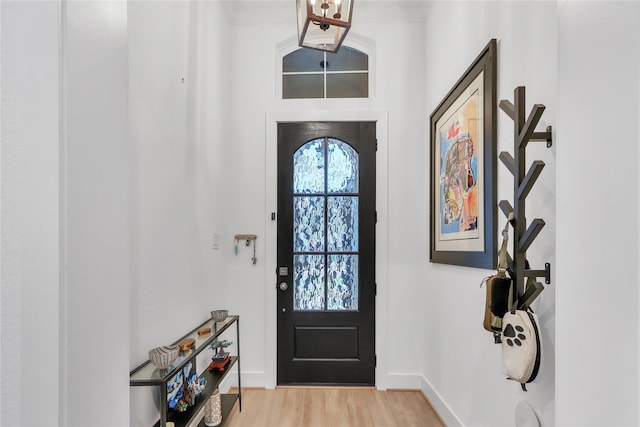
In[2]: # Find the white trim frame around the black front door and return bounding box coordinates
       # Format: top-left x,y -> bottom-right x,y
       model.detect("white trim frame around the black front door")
263,111 -> 389,390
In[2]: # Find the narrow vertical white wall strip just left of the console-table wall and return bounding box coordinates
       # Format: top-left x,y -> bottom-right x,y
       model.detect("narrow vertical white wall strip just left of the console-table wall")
63,1 -> 131,426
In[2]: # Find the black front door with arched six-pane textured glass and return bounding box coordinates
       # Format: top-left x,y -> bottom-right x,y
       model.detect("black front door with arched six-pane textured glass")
276,122 -> 376,385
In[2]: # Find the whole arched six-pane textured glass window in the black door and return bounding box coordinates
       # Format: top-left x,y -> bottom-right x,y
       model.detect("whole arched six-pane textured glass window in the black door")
293,138 -> 359,311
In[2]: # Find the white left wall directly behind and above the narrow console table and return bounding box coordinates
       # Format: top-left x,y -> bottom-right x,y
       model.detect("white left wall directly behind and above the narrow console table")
128,1 -> 231,426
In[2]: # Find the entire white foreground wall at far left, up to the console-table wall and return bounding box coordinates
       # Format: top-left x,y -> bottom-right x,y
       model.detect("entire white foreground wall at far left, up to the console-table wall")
1,1 -> 130,426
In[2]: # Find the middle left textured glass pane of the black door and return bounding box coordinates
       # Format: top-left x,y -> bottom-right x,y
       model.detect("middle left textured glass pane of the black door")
293,196 -> 325,252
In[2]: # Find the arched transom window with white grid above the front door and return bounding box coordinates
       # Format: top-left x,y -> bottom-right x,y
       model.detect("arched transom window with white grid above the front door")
282,46 -> 369,99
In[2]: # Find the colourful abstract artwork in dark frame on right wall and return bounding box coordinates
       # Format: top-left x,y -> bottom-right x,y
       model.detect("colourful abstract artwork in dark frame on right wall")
430,39 -> 497,269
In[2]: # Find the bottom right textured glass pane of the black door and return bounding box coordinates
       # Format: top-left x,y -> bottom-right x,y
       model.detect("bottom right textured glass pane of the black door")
327,255 -> 358,310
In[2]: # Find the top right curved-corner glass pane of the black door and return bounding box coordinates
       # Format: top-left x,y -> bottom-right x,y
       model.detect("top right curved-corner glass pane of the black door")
327,139 -> 358,193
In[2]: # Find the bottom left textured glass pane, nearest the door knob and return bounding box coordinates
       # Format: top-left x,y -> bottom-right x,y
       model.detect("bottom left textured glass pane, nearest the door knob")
293,255 -> 325,310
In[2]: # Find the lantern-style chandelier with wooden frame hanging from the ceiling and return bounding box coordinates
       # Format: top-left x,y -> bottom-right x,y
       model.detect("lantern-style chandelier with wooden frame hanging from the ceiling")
296,0 -> 353,53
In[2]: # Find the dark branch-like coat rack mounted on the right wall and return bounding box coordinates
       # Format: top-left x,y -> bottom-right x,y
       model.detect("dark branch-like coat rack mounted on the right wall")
498,86 -> 552,309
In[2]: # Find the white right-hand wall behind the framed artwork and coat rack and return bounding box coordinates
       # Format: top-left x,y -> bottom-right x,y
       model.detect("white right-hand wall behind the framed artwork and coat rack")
419,1 -> 560,426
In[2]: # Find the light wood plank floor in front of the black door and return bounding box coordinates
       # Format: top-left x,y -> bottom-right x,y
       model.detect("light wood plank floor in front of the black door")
225,387 -> 445,427
